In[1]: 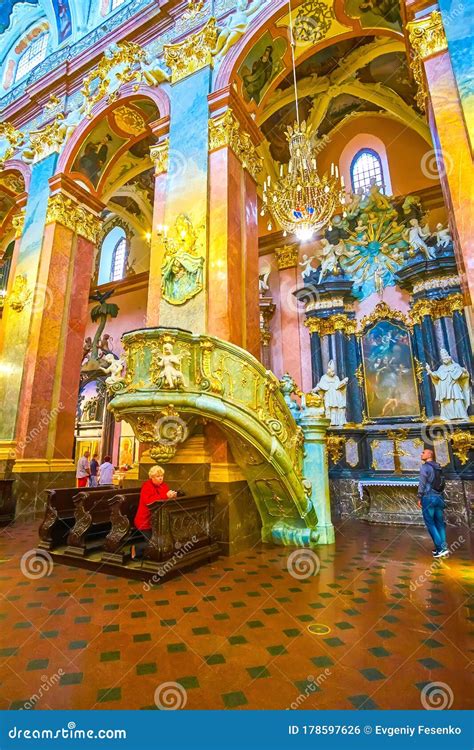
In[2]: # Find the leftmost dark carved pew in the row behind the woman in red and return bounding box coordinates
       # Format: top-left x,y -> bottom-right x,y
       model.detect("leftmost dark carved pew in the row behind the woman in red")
38,485 -> 113,550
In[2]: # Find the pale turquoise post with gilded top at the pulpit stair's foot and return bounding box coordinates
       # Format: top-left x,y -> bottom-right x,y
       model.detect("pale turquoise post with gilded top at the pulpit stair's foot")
298,406 -> 335,544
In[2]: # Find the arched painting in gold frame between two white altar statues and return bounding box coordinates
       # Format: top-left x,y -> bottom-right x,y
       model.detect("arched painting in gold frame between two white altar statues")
362,320 -> 420,419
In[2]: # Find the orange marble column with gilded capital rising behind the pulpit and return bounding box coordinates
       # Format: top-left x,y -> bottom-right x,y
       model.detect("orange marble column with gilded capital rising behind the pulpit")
207,88 -> 261,358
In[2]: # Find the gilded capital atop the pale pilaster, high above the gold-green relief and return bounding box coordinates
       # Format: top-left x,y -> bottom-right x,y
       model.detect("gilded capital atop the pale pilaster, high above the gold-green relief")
163,18 -> 218,83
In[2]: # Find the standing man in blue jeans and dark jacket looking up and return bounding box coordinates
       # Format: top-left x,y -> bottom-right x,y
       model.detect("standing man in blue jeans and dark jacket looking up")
418,448 -> 449,558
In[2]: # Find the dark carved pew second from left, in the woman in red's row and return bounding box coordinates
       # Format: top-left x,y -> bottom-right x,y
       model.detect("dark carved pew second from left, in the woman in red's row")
64,486 -> 140,557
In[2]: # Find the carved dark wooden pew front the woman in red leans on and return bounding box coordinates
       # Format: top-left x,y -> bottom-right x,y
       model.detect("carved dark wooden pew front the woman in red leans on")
143,493 -> 219,583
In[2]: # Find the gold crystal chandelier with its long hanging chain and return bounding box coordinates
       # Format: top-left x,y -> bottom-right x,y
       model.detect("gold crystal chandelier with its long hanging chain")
261,0 -> 345,240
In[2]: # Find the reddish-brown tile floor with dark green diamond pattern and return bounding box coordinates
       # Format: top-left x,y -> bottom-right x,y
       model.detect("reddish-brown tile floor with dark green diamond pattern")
0,522 -> 474,709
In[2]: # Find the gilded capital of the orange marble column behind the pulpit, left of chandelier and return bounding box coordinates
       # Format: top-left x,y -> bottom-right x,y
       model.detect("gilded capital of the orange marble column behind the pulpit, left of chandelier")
209,109 -> 263,180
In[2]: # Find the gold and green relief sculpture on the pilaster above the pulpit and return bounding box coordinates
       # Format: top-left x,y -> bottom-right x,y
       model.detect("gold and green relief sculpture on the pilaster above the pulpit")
161,214 -> 204,305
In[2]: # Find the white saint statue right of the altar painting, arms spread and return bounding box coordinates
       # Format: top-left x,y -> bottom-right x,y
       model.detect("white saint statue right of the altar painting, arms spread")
426,349 -> 471,420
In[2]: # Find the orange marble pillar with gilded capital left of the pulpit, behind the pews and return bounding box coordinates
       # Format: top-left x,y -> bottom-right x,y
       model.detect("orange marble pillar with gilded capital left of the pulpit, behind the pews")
15,175 -> 103,471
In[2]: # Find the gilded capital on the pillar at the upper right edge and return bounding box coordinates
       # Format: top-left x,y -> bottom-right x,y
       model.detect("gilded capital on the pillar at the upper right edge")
407,10 -> 448,111
